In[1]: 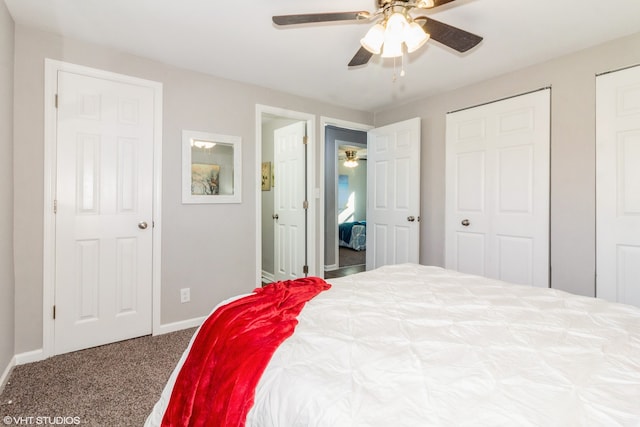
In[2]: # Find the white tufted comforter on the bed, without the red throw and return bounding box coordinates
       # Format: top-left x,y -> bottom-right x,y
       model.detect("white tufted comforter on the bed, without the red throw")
146,264 -> 640,427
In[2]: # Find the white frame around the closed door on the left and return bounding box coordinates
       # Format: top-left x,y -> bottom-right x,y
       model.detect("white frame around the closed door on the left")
42,58 -> 162,358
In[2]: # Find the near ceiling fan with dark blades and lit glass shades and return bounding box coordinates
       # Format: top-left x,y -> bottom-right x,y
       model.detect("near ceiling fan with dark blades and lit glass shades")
272,0 -> 482,67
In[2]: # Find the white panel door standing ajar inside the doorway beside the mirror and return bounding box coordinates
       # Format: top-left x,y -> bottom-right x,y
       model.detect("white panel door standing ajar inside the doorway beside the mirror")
273,122 -> 306,280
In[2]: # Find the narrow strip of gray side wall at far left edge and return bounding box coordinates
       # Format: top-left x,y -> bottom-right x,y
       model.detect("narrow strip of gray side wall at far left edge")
0,2 -> 15,388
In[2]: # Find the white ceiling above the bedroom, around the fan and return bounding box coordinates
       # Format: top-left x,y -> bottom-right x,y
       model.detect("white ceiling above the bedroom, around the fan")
5,0 -> 640,111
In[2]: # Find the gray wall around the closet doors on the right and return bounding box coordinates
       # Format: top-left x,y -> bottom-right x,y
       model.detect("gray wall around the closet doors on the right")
375,33 -> 640,296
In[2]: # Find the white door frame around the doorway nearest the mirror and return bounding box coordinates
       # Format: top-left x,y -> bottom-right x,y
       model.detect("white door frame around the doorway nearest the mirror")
253,104 -> 318,287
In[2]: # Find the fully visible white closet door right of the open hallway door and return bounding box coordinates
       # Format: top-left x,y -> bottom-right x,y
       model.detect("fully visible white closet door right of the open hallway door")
445,90 -> 550,287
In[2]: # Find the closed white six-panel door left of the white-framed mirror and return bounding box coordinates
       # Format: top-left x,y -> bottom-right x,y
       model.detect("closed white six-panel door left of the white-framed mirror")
54,71 -> 154,354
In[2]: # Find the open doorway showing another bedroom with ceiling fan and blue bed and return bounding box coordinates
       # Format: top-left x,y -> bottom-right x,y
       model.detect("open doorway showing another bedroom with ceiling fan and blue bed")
324,126 -> 367,278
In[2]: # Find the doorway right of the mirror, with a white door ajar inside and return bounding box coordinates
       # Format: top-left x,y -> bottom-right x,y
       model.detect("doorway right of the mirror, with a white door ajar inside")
256,106 -> 316,284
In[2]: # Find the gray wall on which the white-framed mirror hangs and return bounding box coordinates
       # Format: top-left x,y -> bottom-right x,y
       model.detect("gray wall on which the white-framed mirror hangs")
12,25 -> 373,353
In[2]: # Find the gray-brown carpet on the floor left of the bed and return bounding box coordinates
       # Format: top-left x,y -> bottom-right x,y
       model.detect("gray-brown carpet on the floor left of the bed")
0,328 -> 195,427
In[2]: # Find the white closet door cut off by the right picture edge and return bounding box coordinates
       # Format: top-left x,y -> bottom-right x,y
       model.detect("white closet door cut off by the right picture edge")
596,67 -> 640,307
